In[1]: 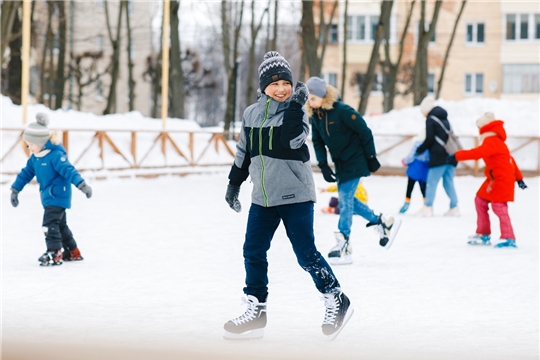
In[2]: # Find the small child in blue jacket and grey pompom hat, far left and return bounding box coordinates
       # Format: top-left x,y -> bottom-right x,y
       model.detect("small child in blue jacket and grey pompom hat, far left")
11,113 -> 92,266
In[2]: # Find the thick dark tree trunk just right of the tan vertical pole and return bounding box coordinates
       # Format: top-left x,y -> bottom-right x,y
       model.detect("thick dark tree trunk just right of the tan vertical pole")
169,1 -> 186,119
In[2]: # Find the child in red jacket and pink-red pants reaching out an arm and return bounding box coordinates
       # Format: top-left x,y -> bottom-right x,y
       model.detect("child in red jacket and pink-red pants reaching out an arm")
448,112 -> 527,248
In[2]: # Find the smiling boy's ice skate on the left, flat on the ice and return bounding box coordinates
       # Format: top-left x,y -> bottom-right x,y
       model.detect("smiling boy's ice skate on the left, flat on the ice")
223,295 -> 266,340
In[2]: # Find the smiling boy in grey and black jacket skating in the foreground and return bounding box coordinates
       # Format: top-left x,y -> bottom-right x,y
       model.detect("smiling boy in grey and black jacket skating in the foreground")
224,51 -> 353,340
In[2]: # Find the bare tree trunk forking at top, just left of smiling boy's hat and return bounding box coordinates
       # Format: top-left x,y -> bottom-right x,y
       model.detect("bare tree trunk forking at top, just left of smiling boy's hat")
221,0 -> 244,136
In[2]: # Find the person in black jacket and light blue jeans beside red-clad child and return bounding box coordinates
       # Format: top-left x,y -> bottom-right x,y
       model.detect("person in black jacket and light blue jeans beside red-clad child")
416,96 -> 460,216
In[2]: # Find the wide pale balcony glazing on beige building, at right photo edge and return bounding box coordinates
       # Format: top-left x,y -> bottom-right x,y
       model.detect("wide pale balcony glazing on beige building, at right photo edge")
502,64 -> 540,94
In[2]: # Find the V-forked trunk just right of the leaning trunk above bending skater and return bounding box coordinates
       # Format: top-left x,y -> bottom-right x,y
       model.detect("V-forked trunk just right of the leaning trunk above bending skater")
383,0 -> 416,113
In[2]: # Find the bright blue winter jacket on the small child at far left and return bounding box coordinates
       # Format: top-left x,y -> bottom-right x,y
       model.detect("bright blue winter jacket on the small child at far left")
11,141 -> 84,209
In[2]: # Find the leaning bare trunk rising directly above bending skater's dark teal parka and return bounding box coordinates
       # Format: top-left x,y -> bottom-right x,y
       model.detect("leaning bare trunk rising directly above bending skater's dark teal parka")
358,1 -> 394,115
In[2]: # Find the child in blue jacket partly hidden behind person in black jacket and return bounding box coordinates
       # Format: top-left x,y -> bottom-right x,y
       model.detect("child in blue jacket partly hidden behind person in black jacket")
399,129 -> 429,214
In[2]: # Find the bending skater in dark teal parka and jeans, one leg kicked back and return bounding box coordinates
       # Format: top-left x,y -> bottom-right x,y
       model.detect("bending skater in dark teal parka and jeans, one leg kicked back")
306,77 -> 400,264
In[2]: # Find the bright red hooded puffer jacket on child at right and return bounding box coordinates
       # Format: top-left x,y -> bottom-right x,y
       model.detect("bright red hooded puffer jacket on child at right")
455,120 -> 523,202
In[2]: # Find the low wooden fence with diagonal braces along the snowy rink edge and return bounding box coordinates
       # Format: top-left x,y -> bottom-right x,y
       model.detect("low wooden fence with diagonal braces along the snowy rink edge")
0,128 -> 540,176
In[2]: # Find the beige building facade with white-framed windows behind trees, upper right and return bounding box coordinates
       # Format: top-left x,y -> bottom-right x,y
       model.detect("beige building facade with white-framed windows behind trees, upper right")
322,1 -> 540,114
